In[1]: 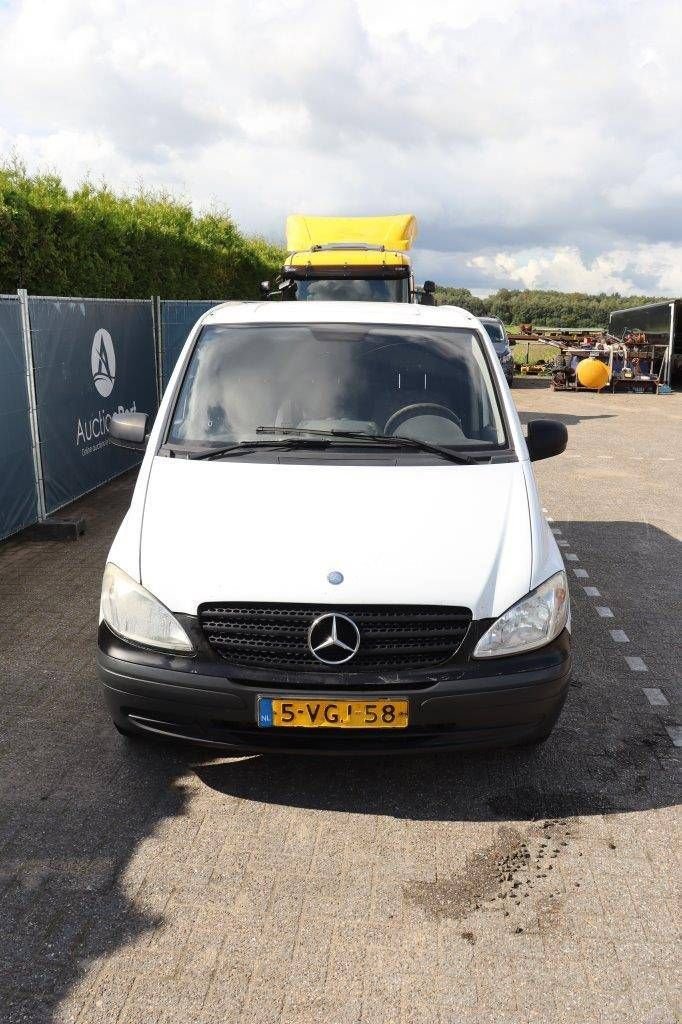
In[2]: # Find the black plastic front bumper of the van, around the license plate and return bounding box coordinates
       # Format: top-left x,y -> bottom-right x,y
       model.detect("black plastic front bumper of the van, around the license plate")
97,627 -> 570,754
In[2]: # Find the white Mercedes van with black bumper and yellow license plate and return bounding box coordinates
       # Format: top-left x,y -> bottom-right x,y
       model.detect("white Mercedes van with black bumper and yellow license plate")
98,302 -> 570,754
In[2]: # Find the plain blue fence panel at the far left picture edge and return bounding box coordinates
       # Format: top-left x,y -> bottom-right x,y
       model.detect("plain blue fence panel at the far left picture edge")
0,295 -> 38,539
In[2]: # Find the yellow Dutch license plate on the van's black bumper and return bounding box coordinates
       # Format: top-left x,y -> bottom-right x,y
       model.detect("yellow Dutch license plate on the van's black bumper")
258,697 -> 410,729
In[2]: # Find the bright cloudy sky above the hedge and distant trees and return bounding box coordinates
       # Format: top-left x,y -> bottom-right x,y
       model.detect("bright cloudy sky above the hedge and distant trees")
0,0 -> 682,295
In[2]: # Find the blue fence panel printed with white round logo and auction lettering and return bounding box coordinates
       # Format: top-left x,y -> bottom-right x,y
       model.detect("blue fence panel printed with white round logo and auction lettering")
29,297 -> 157,513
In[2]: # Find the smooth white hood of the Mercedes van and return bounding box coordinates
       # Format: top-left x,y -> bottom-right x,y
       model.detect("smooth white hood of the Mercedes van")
140,457 -> 531,618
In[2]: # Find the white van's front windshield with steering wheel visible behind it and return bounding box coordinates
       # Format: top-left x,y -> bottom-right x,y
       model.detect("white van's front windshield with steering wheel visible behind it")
167,324 -> 506,449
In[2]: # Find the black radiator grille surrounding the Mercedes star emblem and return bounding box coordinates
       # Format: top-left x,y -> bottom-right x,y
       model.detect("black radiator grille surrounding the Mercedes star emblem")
199,603 -> 471,674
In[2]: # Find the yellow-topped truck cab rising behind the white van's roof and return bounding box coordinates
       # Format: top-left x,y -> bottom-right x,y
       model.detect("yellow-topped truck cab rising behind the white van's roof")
261,213 -> 417,302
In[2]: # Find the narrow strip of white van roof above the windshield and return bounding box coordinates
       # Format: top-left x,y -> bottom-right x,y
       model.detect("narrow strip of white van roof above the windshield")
202,301 -> 478,329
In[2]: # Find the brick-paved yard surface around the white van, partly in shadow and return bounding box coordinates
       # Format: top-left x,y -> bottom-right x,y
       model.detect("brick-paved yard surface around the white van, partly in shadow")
0,381 -> 682,1024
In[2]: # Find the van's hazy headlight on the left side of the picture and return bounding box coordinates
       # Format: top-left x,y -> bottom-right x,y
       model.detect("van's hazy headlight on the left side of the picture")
99,562 -> 194,654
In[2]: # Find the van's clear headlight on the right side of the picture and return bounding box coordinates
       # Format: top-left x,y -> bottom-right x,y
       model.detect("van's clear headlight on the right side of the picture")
473,571 -> 569,657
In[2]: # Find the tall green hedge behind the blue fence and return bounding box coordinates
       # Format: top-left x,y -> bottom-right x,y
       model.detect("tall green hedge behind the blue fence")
0,164 -> 283,299
